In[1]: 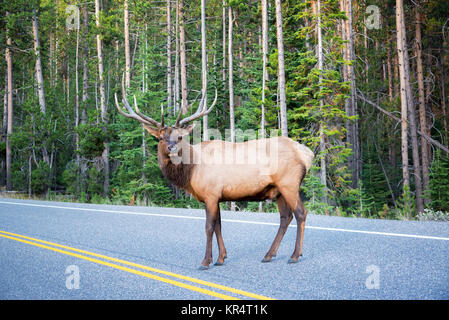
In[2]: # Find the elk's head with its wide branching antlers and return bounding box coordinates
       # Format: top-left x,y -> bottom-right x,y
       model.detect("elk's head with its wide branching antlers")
115,79 -> 217,162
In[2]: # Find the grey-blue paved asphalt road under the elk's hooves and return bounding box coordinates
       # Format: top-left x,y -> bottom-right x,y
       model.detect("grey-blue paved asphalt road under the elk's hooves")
0,198 -> 449,300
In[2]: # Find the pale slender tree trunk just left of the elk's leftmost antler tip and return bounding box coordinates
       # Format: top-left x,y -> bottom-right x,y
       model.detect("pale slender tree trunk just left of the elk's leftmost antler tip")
95,0 -> 109,196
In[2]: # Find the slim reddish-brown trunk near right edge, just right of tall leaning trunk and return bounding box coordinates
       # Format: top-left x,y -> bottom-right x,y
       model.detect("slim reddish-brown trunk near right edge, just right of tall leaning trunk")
415,7 -> 430,203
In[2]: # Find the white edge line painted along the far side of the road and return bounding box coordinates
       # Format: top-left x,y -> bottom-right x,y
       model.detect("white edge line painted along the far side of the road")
0,201 -> 449,241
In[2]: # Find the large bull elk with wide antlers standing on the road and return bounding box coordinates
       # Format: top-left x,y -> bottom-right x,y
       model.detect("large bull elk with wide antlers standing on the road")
115,84 -> 314,270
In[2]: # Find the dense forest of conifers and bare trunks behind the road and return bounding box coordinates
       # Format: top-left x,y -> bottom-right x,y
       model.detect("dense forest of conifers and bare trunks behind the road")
0,0 -> 449,219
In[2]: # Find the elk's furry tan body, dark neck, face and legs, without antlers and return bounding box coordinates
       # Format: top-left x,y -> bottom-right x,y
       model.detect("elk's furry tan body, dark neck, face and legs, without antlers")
152,128 -> 313,268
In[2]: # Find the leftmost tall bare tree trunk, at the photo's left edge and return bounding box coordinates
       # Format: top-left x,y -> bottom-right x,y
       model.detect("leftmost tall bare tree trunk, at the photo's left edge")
5,12 -> 13,191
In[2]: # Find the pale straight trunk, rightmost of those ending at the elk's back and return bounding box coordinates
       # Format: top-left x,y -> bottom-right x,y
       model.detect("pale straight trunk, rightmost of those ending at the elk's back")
275,0 -> 288,137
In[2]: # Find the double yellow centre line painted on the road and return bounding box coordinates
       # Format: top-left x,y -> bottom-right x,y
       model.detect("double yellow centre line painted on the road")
0,230 -> 271,300
